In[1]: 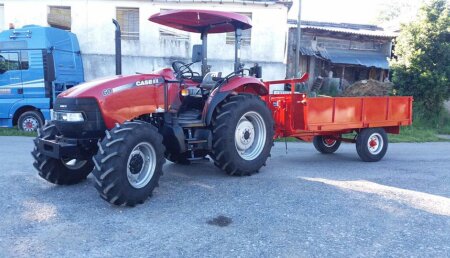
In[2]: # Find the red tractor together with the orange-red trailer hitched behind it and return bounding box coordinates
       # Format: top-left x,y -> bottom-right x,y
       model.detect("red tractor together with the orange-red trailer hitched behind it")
32,10 -> 413,206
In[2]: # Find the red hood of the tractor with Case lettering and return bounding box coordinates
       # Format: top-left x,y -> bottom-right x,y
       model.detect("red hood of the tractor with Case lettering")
56,69 -> 178,128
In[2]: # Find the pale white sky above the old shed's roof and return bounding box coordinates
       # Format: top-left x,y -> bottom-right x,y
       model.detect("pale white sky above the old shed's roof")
289,0 -> 422,24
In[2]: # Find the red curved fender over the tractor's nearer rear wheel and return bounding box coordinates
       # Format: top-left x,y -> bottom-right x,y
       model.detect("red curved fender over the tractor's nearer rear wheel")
202,77 -> 269,125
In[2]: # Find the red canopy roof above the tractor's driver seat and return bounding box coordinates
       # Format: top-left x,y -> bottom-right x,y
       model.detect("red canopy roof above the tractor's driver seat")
149,10 -> 252,33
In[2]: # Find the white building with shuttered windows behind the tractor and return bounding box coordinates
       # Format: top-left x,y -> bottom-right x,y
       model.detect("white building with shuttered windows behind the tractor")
0,0 -> 291,80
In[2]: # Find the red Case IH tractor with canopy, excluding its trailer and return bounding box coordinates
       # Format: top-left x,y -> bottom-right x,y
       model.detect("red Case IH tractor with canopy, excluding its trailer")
32,10 -> 274,206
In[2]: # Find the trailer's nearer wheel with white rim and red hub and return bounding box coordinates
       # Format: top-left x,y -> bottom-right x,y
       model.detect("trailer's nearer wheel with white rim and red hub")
356,128 -> 388,162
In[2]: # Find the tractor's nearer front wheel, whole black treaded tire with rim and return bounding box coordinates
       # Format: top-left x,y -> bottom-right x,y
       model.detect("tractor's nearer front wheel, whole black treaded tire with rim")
92,121 -> 165,206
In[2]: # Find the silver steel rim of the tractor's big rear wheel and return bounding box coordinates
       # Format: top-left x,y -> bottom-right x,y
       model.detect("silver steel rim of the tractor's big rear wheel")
234,111 -> 267,160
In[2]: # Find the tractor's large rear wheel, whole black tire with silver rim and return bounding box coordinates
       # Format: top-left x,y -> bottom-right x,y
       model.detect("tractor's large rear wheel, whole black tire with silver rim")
211,94 -> 274,176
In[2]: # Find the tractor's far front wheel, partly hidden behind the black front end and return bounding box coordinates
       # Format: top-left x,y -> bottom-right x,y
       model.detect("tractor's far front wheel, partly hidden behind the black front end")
31,122 -> 94,185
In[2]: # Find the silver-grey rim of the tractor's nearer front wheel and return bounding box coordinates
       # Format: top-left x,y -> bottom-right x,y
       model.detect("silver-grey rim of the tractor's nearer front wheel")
127,142 -> 156,189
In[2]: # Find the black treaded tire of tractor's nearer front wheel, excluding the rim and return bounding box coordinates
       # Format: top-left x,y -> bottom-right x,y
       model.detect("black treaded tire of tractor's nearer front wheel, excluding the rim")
92,121 -> 165,207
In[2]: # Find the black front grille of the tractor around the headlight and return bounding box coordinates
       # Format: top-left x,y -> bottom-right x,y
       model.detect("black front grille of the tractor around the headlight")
53,98 -> 106,138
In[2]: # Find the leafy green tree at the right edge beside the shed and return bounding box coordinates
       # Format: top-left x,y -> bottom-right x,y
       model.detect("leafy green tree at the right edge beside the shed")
391,0 -> 450,124
